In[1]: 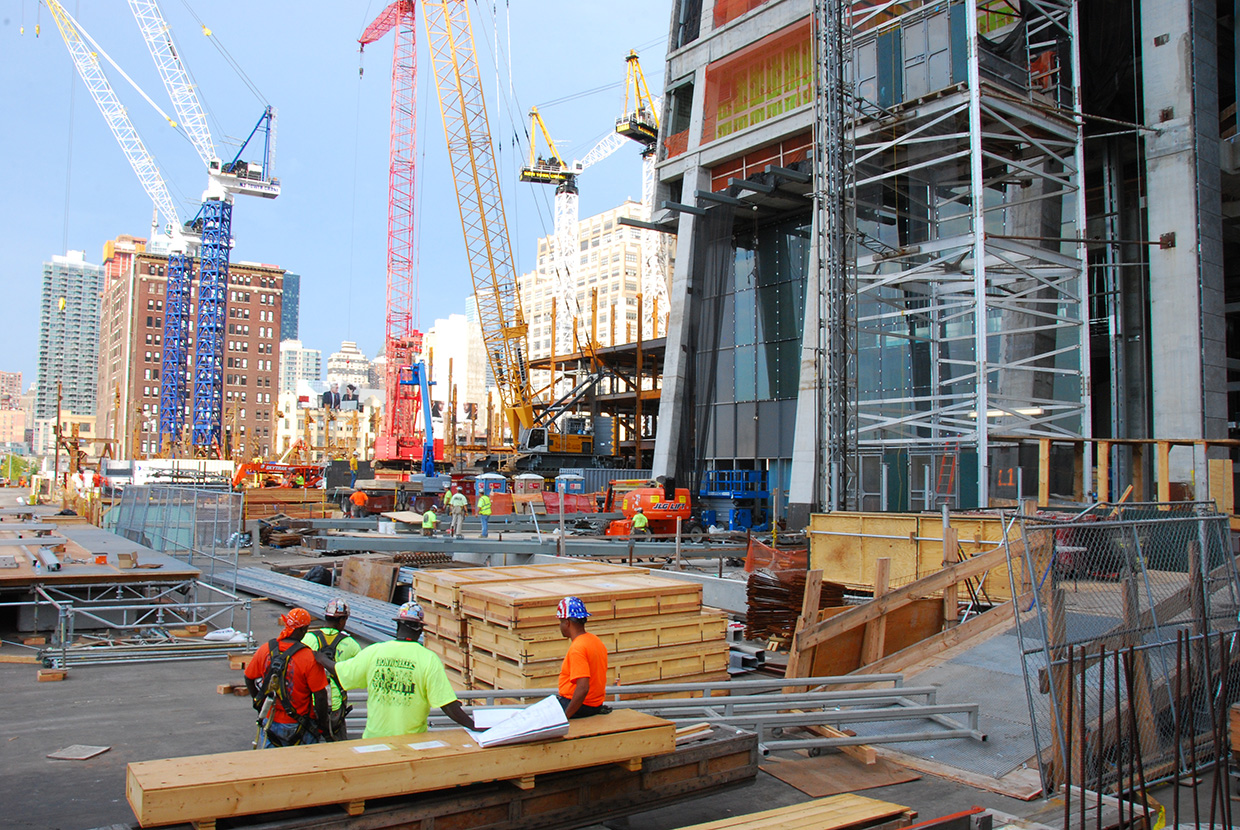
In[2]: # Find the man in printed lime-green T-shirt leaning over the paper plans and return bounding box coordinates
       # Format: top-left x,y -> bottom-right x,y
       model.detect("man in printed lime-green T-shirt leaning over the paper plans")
316,602 -> 474,738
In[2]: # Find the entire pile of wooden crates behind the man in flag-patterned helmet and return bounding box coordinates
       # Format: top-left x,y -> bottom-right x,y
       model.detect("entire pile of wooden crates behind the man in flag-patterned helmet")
413,562 -> 729,689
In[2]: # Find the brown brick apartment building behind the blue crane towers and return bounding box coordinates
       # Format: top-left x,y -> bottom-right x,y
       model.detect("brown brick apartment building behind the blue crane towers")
99,237 -> 284,458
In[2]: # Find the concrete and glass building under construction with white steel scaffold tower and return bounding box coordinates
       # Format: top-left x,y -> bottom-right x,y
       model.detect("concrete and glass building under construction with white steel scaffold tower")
653,0 -> 1240,526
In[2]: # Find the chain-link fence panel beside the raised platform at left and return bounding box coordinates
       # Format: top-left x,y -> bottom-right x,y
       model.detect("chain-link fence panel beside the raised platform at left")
105,485 -> 244,589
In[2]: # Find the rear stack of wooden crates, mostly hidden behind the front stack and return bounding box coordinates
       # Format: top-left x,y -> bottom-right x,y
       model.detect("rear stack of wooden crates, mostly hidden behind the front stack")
413,562 -> 631,684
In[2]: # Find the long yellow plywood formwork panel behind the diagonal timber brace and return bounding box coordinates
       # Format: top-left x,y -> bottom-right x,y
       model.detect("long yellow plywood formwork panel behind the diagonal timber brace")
810,511 -> 1019,602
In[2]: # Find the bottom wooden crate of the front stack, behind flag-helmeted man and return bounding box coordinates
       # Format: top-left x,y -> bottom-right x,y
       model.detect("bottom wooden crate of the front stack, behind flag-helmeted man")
470,643 -> 729,689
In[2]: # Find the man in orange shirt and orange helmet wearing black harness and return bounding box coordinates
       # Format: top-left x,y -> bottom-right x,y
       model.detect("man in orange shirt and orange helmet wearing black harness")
246,608 -> 331,749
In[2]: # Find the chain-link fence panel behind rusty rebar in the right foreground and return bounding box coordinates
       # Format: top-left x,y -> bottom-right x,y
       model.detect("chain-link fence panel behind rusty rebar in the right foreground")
1009,502 -> 1240,793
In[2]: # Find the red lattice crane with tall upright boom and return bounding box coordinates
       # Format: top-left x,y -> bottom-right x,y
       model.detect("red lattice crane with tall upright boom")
357,0 -> 430,462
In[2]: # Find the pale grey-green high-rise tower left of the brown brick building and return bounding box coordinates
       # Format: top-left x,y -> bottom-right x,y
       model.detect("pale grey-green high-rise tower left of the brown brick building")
35,251 -> 103,421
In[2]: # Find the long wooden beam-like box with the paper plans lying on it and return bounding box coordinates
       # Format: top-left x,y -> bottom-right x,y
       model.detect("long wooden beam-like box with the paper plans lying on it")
125,710 -> 676,828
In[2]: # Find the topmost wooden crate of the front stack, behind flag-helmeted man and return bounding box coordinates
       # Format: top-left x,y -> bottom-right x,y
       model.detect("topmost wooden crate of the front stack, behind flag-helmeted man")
460,574 -> 702,629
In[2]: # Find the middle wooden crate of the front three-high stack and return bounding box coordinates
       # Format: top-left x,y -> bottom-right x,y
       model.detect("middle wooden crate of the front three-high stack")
469,608 -> 728,664
